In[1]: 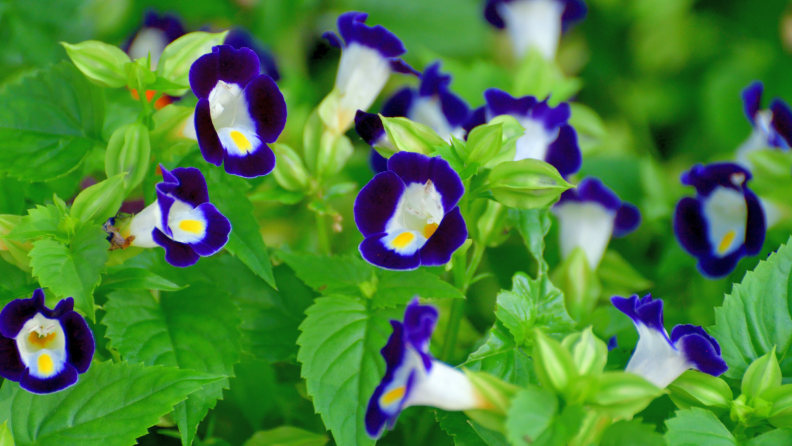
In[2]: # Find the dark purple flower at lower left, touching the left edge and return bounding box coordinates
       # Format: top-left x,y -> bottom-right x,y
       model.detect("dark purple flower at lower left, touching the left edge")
0,288 -> 95,394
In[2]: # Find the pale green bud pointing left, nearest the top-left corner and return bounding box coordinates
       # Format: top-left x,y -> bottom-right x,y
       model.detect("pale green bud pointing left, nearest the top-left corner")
61,40 -> 130,88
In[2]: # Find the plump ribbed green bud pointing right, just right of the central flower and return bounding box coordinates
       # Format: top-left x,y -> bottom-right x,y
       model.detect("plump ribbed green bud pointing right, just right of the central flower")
489,159 -> 572,209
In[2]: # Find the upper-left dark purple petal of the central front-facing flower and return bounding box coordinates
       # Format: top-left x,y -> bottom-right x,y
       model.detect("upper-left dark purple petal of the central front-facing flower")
354,172 -> 404,237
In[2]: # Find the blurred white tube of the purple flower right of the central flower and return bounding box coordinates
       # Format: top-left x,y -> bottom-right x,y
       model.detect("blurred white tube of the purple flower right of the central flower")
553,201 -> 616,270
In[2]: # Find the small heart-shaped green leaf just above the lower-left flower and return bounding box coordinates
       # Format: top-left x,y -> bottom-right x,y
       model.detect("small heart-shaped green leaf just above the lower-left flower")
29,225 -> 110,320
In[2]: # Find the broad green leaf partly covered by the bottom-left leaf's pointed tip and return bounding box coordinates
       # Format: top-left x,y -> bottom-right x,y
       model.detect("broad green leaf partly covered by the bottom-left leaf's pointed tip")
102,286 -> 240,446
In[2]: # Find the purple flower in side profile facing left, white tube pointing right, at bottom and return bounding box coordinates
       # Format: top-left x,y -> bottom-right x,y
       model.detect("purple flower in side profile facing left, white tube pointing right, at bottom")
366,298 -> 489,439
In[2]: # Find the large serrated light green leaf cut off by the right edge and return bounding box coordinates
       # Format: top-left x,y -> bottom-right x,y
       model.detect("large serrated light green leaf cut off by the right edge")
710,238 -> 792,379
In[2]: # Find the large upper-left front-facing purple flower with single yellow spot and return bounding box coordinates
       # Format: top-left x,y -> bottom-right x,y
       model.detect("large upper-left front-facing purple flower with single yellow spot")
183,45 -> 286,178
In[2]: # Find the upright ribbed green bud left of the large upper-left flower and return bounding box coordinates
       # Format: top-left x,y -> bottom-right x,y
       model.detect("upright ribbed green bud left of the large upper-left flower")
105,122 -> 151,196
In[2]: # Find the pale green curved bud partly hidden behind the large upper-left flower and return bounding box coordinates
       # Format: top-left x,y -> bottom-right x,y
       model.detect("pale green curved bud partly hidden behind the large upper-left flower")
157,31 -> 228,96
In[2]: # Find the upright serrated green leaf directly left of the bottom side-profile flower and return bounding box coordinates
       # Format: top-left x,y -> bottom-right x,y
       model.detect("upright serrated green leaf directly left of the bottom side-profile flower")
297,296 -> 393,446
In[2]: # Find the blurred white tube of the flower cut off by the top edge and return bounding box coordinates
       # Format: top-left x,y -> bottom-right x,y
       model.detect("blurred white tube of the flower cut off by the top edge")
498,0 -> 564,60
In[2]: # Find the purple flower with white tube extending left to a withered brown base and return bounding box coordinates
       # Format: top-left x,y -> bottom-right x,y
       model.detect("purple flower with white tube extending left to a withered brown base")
105,166 -> 231,267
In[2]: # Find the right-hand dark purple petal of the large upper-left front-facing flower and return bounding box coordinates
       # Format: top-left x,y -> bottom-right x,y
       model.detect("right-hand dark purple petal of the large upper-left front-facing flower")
245,75 -> 286,143
